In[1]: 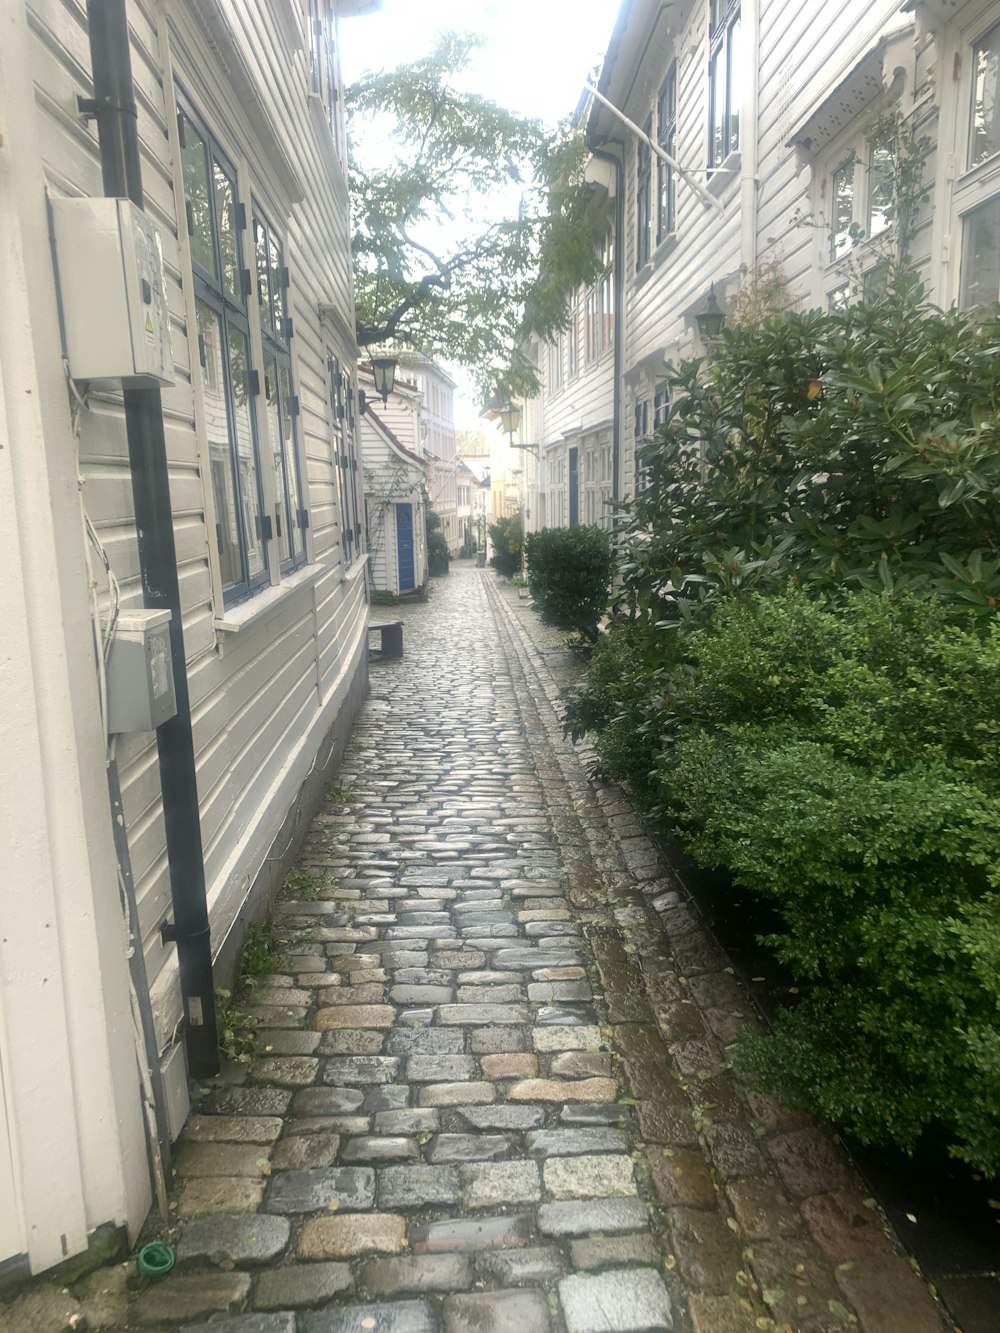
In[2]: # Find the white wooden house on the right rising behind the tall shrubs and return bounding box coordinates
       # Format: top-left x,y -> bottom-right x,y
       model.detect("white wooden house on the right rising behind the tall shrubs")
539,0 -> 1000,527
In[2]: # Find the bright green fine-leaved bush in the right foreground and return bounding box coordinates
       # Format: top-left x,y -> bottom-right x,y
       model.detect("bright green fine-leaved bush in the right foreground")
659,593 -> 1000,1173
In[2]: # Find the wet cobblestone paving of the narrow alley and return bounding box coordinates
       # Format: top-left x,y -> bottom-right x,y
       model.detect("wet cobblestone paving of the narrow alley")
47,565 -> 948,1333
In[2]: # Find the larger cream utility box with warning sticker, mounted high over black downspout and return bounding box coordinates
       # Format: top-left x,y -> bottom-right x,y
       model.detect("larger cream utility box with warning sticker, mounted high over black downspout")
51,199 -> 173,389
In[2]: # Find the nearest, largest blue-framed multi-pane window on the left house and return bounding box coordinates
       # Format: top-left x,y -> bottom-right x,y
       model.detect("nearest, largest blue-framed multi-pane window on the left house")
177,105 -> 271,603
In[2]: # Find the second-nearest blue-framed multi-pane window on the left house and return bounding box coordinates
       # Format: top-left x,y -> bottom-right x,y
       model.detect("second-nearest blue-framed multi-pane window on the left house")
253,204 -> 308,572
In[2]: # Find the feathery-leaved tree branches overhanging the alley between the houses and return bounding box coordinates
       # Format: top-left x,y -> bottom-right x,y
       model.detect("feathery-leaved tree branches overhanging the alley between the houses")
347,33 -> 607,397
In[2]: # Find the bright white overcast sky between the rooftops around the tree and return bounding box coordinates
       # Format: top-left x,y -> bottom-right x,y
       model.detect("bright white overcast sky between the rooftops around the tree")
340,0 -> 620,431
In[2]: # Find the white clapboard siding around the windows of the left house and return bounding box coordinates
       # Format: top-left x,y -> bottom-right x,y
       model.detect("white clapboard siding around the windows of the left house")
29,0 -> 367,1046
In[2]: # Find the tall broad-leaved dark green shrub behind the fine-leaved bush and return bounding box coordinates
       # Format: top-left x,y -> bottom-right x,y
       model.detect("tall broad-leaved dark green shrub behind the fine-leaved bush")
623,279 -> 1000,623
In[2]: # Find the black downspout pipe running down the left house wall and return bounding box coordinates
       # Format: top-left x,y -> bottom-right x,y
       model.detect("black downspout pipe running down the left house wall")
87,0 -> 219,1078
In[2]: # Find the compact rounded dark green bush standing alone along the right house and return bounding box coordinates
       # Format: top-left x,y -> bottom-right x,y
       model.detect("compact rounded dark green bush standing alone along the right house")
524,527 -> 612,640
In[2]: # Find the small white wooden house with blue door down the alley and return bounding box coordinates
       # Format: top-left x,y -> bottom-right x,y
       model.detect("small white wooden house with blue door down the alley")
361,391 -> 431,596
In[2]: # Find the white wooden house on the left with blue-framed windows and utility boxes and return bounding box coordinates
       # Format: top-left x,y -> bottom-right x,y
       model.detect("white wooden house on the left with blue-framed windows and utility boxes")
0,0 -> 373,1274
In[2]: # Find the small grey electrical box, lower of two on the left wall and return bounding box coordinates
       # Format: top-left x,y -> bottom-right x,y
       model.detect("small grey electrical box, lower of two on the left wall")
108,611 -> 177,733
